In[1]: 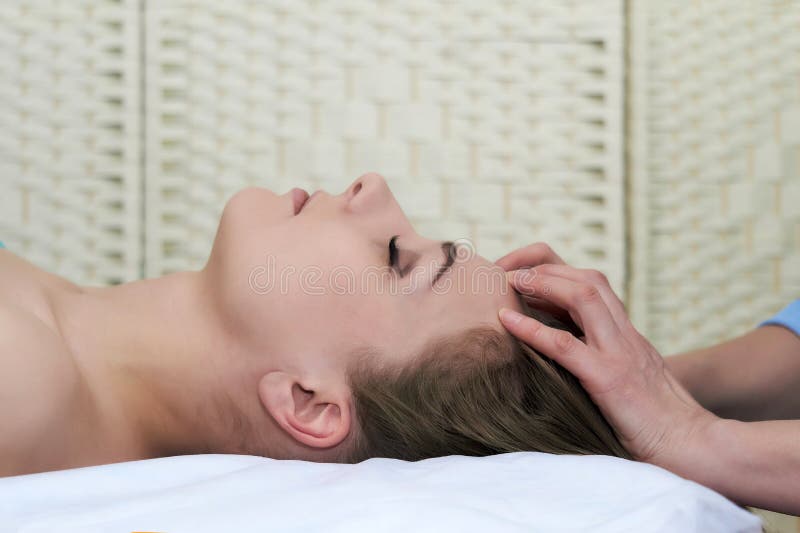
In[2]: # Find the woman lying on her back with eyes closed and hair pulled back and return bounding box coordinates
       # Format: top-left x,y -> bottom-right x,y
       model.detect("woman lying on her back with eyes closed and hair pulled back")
0,174 -> 628,475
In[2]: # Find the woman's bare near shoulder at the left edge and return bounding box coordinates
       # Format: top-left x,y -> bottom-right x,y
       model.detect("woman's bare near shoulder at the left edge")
0,298 -> 80,476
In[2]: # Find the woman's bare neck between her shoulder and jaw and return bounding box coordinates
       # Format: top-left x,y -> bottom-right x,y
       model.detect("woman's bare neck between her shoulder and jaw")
54,271 -> 256,459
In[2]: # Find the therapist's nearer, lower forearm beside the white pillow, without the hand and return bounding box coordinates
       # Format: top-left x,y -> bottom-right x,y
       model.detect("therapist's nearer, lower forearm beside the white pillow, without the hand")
654,419 -> 800,515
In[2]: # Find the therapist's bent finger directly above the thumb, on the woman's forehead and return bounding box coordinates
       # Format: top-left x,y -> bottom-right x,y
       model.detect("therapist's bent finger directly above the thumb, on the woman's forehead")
509,267 -> 620,347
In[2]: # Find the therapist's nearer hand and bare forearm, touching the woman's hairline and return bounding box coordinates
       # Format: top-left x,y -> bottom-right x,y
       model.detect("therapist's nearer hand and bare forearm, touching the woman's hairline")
497,243 -> 800,514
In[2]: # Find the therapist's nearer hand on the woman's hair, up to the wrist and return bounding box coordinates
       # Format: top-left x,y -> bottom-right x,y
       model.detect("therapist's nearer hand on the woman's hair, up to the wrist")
500,264 -> 718,468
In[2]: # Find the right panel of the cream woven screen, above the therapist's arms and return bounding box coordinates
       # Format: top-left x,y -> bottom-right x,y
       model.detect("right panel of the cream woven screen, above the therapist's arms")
629,0 -> 800,353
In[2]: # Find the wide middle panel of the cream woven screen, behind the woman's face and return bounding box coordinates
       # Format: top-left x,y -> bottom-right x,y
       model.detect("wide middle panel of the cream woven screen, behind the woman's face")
145,0 -> 625,290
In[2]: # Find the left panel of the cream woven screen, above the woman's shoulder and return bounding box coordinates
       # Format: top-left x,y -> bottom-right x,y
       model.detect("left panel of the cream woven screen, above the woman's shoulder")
0,0 -> 141,285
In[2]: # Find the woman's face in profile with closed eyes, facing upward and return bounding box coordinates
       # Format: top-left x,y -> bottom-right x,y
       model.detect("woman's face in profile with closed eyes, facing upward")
205,173 -> 520,375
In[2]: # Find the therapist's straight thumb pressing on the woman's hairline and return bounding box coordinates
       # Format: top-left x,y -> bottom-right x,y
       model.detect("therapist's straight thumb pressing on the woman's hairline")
499,307 -> 596,380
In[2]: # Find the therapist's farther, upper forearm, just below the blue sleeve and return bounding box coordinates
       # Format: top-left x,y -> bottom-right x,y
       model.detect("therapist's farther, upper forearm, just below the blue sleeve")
665,326 -> 800,420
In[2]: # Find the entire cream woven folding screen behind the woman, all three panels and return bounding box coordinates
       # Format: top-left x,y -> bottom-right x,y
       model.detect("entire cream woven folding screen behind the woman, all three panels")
0,0 -> 800,358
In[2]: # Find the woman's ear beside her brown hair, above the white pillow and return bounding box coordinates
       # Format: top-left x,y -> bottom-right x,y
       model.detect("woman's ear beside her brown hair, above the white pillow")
258,370 -> 351,448
